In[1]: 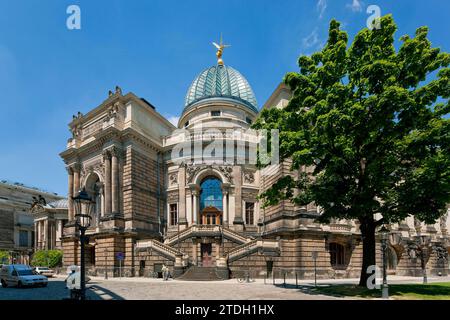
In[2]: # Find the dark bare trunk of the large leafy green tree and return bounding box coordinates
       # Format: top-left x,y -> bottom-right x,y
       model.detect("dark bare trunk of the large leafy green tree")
359,217 -> 376,287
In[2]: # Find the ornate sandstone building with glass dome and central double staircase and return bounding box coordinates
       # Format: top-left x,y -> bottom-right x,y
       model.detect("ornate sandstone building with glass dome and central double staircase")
61,44 -> 449,279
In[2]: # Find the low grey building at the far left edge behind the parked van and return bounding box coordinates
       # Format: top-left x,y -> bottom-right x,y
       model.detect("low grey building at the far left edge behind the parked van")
0,180 -> 62,263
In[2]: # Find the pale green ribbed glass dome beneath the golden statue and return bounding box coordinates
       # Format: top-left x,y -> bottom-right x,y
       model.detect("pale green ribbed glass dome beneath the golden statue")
183,64 -> 258,112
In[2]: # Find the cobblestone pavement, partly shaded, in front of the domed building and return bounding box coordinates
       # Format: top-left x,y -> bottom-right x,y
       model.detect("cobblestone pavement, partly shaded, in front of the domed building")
0,277 -> 450,300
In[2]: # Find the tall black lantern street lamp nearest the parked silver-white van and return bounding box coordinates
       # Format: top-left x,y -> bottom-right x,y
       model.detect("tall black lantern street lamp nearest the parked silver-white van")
72,188 -> 95,300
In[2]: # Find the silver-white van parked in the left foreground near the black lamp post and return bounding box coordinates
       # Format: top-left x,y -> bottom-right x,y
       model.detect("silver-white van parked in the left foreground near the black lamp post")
0,264 -> 48,288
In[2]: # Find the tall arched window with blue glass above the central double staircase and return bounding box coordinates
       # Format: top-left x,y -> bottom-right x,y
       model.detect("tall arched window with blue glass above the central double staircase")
200,177 -> 223,224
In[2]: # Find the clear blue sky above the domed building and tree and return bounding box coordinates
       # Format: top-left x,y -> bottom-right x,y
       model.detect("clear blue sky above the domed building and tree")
0,0 -> 450,195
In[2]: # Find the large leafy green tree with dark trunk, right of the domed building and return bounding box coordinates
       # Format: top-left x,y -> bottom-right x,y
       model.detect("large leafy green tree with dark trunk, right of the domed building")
253,15 -> 450,286
